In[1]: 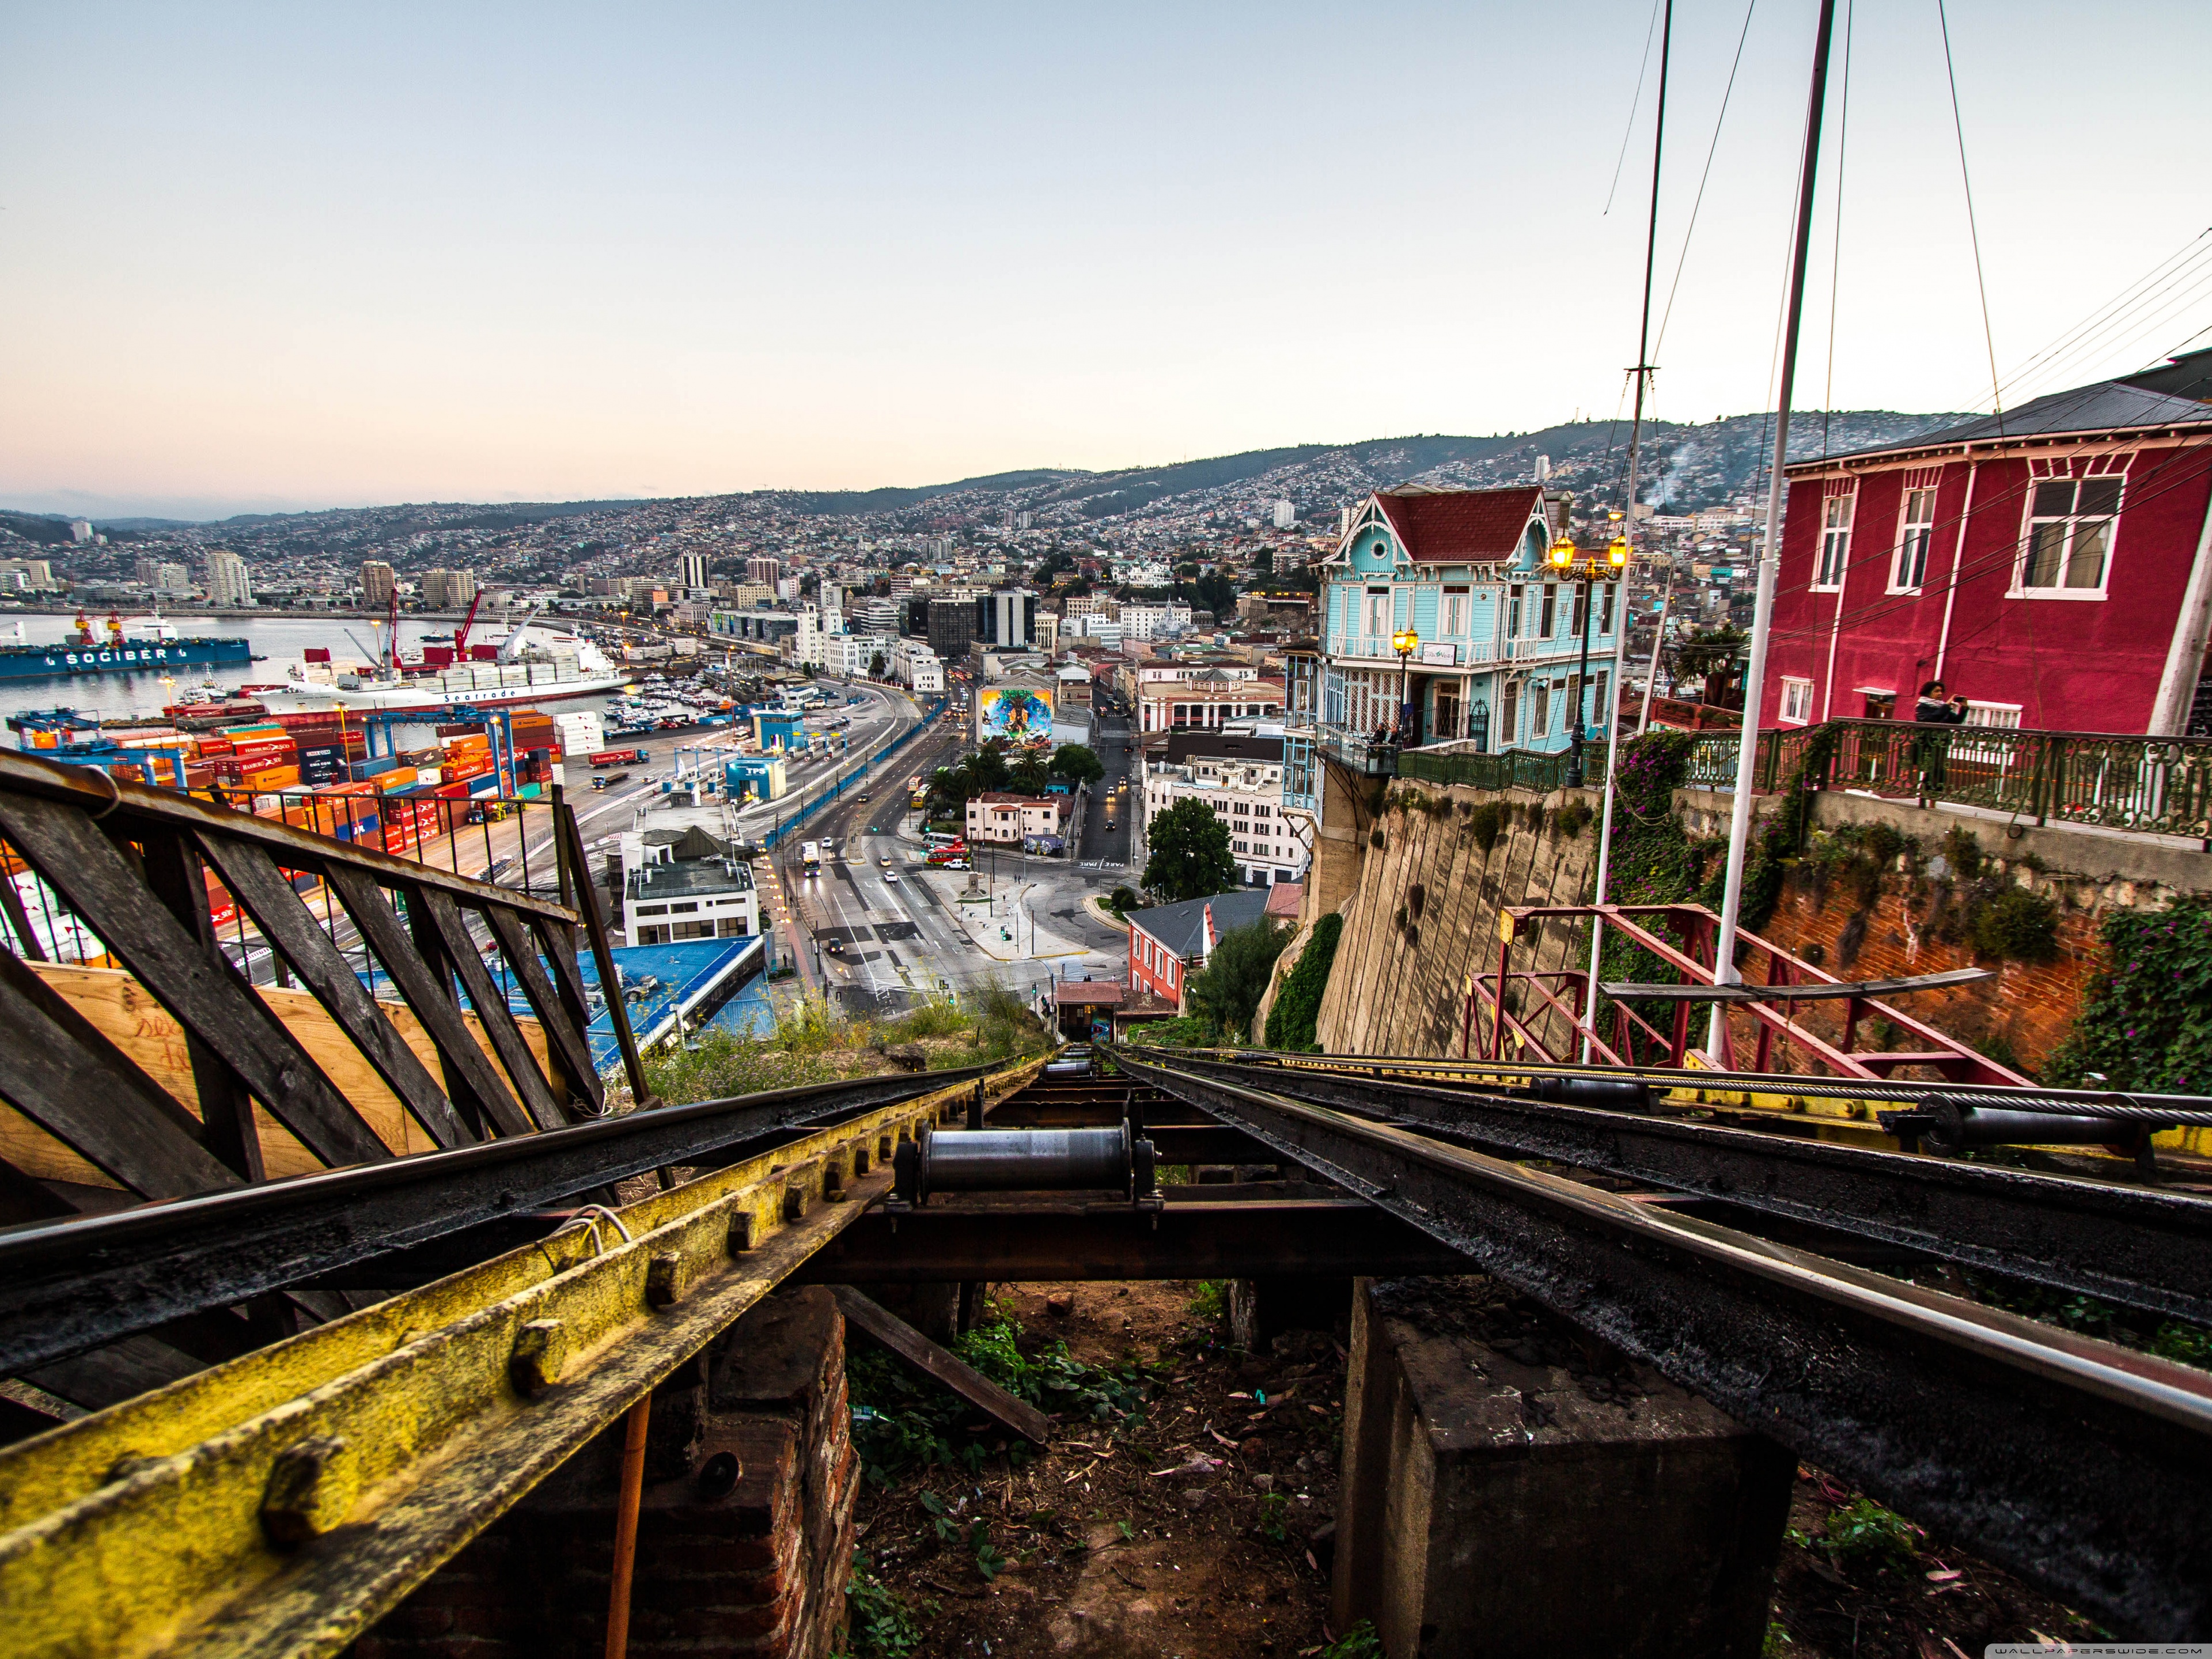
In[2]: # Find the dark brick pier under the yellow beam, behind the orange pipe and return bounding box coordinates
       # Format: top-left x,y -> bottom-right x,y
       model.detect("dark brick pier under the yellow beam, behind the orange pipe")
354,1287 -> 858,1659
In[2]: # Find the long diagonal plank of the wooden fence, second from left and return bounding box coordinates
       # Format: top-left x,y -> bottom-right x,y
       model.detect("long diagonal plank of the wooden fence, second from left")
0,792 -> 392,1166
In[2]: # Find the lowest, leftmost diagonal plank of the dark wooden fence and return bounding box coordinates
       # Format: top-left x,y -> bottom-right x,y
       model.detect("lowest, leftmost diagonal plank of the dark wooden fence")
0,951 -> 243,1199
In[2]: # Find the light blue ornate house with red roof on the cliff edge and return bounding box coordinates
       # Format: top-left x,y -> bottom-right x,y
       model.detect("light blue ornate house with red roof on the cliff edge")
1318,484 -> 1619,756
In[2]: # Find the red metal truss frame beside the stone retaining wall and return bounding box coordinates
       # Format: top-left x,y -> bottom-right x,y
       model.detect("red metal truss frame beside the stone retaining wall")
1460,905 -> 2028,1084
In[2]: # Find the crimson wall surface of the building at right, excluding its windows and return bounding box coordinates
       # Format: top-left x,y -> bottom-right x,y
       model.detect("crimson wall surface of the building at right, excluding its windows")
1761,442 -> 2212,732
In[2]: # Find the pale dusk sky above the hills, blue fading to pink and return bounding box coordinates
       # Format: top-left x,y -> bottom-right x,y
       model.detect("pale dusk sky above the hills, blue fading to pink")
0,0 -> 2212,518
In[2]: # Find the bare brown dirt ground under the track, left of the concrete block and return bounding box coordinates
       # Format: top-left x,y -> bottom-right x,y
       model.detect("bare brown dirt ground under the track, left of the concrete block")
854,1281 -> 1345,1659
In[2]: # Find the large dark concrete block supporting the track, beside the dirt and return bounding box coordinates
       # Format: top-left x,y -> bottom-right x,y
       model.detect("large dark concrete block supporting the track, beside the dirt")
1334,1277 -> 1796,1659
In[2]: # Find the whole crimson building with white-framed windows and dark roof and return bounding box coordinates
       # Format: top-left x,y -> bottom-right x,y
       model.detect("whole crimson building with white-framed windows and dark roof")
1759,352 -> 2212,737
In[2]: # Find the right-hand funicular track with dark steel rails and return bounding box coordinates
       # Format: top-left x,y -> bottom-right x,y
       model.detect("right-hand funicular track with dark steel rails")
1115,1048 -> 2212,1639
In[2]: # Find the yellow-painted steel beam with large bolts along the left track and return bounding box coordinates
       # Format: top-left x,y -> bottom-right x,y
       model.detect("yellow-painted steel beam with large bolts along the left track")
0,1062 -> 1042,1657
